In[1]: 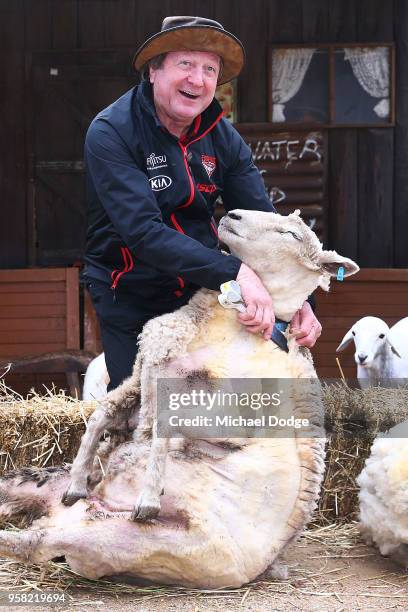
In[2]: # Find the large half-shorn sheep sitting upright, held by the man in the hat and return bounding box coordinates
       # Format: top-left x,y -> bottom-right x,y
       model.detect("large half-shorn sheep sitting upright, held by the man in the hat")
0,210 -> 358,588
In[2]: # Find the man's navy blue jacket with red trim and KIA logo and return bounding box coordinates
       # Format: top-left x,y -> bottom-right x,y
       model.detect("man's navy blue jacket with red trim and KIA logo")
85,82 -> 274,301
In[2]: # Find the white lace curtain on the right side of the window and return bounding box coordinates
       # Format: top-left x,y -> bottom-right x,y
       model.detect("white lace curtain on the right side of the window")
344,47 -> 390,118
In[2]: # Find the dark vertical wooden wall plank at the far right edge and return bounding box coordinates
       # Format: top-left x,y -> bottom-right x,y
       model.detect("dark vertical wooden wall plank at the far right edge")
394,0 -> 408,267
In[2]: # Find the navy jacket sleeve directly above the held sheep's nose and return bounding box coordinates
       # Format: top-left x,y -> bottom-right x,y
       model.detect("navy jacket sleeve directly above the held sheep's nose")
222,126 -> 276,212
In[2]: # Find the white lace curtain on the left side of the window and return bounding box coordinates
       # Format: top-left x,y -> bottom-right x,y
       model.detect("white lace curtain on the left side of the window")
272,49 -> 316,122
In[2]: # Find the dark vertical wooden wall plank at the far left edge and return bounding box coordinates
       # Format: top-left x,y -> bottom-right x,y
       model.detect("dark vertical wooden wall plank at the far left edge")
0,0 -> 27,268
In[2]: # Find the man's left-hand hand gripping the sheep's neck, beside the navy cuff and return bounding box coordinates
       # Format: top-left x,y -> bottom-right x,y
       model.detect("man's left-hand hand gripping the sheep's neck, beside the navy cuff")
237,264 -> 275,340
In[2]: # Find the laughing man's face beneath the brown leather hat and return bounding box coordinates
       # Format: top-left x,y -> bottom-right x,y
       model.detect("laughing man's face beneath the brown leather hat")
150,51 -> 220,127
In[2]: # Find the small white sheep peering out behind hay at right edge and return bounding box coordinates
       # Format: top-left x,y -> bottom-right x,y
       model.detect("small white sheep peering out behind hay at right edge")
336,317 -> 408,388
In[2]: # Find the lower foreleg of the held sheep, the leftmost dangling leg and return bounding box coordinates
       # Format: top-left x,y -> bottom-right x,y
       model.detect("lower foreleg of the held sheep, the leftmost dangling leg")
62,408 -> 111,506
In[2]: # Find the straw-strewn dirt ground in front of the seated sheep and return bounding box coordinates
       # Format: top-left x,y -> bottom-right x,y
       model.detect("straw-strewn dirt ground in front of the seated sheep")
0,526 -> 408,612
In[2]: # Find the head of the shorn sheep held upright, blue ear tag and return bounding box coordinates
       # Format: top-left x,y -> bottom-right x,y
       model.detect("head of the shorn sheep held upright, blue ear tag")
219,209 -> 359,291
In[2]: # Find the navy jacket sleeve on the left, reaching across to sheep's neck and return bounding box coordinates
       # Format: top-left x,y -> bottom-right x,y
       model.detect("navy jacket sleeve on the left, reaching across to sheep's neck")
85,118 -> 241,290
